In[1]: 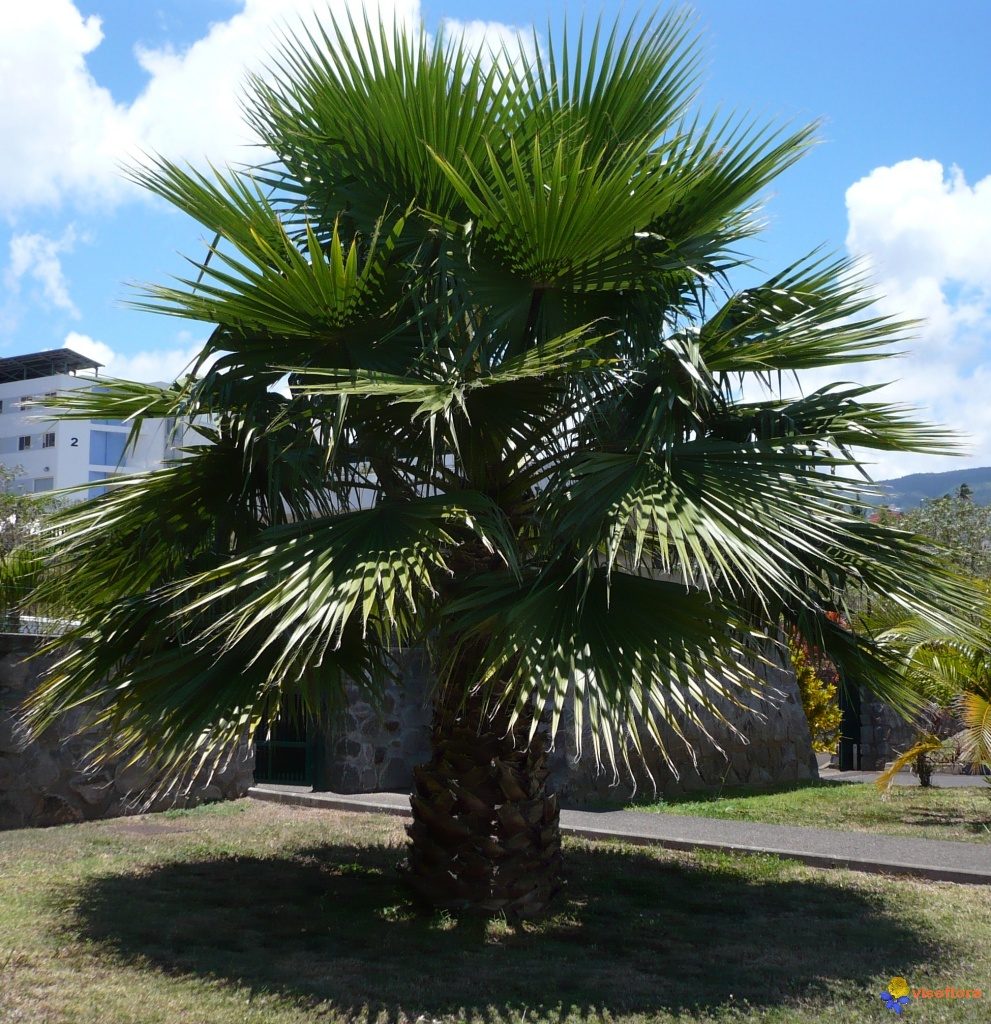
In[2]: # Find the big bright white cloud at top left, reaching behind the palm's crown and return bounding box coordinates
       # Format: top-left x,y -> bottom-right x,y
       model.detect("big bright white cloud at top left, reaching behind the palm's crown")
0,0 -> 532,215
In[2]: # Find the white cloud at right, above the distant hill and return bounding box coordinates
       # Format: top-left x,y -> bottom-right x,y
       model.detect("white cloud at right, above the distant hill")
847,159 -> 991,478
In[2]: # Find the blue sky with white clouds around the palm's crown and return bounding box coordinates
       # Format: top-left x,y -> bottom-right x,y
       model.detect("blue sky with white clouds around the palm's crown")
0,0 -> 991,476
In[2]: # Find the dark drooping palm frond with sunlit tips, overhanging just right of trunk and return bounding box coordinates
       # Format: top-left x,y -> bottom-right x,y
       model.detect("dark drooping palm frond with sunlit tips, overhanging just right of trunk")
441,571 -> 769,774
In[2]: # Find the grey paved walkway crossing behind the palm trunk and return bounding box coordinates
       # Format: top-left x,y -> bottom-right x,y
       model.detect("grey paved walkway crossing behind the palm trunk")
249,785 -> 991,885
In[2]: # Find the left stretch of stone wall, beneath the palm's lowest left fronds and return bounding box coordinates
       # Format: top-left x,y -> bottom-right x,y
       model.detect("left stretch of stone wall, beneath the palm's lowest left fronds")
0,634 -> 254,828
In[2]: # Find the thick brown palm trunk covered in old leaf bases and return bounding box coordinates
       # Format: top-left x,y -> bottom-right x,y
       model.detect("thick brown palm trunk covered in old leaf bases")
404,691 -> 561,921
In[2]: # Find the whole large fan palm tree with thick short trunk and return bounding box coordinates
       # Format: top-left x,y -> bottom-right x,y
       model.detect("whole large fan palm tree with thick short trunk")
23,13 -> 973,916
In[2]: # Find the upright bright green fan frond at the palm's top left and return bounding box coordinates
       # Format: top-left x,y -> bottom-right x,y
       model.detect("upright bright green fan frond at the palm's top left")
246,10 -> 520,231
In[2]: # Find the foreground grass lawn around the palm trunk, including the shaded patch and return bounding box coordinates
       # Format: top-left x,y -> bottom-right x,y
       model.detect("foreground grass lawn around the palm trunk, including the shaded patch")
0,801 -> 991,1024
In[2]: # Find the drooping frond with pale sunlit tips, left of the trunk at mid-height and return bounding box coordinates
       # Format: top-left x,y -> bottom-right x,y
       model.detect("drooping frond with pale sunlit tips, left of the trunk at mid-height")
170,492 -> 517,675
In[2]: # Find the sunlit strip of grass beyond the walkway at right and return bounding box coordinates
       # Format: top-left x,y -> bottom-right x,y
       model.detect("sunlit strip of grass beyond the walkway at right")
628,781 -> 991,843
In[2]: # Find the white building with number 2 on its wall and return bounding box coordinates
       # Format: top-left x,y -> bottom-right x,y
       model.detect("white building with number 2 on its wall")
0,348 -> 180,500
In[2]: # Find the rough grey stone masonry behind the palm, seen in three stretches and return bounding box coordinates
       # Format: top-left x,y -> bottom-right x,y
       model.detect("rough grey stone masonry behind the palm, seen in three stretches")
0,634 -> 817,828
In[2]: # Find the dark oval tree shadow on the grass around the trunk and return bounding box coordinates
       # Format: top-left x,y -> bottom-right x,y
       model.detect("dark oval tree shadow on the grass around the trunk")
66,845 -> 936,1021
